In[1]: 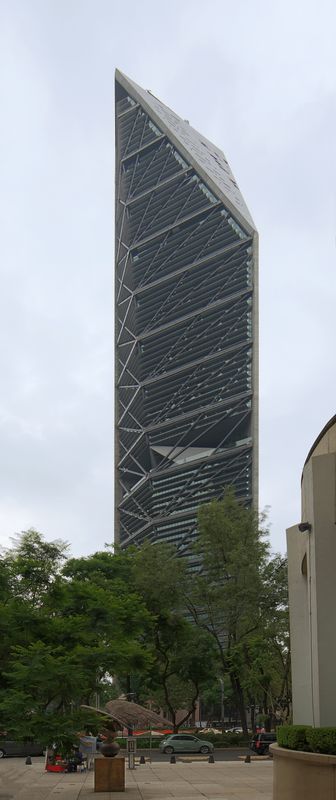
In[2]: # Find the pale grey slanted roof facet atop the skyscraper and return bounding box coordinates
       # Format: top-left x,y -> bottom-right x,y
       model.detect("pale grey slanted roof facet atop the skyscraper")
116,70 -> 256,233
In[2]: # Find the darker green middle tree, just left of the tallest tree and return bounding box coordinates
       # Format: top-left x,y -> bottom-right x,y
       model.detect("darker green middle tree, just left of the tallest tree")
133,544 -> 215,731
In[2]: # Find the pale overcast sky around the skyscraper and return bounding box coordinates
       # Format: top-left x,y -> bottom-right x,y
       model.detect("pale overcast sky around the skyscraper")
0,0 -> 336,555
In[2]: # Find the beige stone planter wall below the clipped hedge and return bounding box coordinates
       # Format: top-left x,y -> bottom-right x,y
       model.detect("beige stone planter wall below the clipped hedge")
270,744 -> 336,800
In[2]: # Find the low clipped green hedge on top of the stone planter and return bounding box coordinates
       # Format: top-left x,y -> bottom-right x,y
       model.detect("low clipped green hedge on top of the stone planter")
277,725 -> 336,755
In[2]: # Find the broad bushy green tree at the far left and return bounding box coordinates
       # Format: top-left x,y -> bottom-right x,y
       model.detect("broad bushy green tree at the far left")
0,531 -> 149,743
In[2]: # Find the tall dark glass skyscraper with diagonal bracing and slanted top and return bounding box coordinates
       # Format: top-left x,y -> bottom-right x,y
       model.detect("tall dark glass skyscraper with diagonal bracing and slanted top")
115,71 -> 258,554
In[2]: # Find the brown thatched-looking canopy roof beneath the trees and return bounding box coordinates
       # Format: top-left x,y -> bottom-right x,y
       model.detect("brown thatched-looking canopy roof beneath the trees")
82,700 -> 172,728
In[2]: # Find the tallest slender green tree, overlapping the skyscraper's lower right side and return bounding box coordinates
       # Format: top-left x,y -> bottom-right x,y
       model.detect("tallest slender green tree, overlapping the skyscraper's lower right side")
187,488 -> 269,734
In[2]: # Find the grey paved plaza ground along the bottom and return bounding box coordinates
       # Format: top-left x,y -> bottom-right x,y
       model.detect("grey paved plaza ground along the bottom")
0,758 -> 273,800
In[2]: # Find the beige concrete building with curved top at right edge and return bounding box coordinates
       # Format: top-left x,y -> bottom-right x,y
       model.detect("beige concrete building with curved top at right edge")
287,418 -> 336,726
